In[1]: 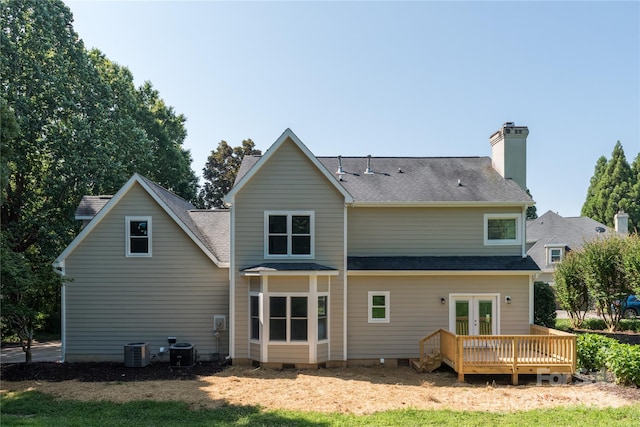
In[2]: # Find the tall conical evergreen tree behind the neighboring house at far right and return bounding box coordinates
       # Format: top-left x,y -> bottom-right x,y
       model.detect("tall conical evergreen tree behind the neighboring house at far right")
582,141 -> 640,230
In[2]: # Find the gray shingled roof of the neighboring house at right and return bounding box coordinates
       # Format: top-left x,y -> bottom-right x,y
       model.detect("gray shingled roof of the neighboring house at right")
527,211 -> 615,271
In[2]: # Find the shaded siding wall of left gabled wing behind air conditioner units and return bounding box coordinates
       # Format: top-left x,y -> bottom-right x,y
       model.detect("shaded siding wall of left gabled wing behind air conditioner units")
65,184 -> 229,362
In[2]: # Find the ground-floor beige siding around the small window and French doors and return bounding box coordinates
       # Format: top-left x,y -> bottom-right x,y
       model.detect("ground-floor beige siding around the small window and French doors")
347,276 -> 529,359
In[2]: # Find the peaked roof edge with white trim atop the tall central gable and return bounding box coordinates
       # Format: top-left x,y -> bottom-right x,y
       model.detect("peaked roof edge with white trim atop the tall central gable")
223,128 -> 353,205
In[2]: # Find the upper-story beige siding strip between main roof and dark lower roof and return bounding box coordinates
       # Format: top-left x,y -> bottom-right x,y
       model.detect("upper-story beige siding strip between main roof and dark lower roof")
348,207 -> 522,256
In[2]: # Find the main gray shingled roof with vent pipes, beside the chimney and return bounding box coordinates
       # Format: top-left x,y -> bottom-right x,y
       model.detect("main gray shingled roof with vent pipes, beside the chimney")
232,137 -> 534,206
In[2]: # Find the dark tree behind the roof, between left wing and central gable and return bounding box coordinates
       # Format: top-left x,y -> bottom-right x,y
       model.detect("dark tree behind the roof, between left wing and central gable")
200,139 -> 262,209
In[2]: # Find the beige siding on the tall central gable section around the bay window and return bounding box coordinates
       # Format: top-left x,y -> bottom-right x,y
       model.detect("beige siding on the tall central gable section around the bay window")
233,140 -> 344,363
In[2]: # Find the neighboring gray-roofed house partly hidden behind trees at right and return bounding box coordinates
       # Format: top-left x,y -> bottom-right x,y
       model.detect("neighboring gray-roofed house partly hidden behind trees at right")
527,211 -> 629,284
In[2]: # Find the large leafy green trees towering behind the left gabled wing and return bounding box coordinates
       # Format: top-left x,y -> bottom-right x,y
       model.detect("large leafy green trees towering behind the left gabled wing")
0,0 -> 197,359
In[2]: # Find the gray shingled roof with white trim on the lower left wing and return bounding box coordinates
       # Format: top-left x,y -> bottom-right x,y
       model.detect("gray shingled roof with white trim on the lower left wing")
53,174 -> 229,267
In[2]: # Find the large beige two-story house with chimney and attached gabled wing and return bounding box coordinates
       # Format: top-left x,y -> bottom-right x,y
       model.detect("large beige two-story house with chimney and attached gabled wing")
55,123 -> 540,367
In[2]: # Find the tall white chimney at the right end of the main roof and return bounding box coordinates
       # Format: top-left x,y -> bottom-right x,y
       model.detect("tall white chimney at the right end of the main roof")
489,122 -> 529,191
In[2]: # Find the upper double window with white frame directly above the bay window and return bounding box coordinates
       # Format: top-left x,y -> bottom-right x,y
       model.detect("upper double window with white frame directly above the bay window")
264,211 -> 315,258
